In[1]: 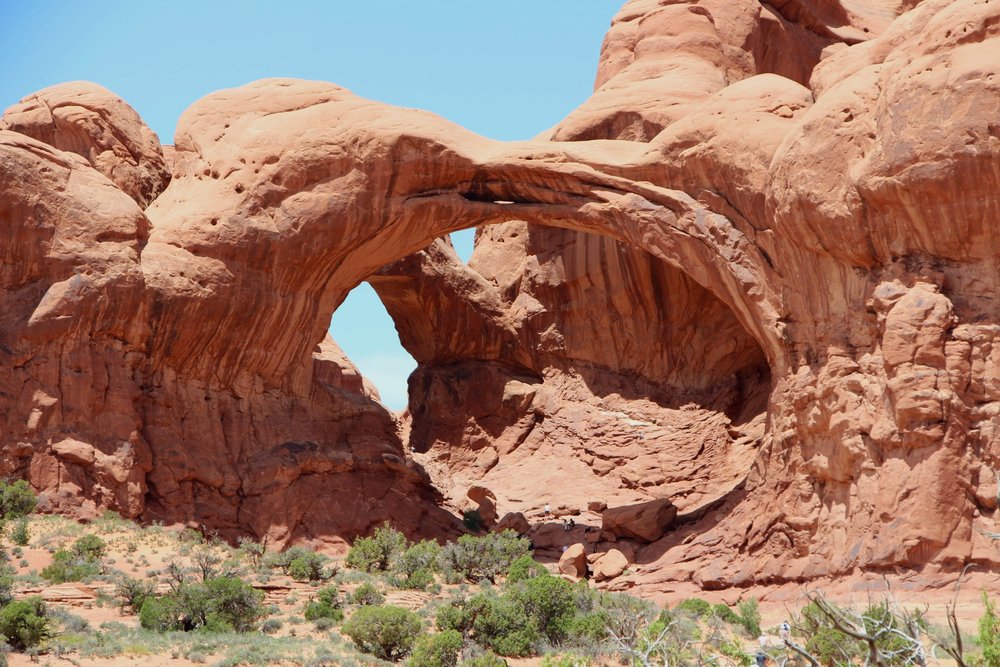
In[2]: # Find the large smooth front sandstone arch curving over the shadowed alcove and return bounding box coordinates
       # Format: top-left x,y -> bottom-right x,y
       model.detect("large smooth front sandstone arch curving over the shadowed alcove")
144,80 -> 784,400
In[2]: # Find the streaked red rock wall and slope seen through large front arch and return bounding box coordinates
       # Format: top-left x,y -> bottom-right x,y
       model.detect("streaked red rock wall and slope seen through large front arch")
360,222 -> 771,549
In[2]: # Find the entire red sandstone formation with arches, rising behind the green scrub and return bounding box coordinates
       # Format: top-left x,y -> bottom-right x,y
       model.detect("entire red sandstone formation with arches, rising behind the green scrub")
0,0 -> 1000,592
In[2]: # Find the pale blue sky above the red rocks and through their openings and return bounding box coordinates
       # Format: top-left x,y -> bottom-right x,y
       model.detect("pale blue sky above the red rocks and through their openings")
0,0 -> 623,409
